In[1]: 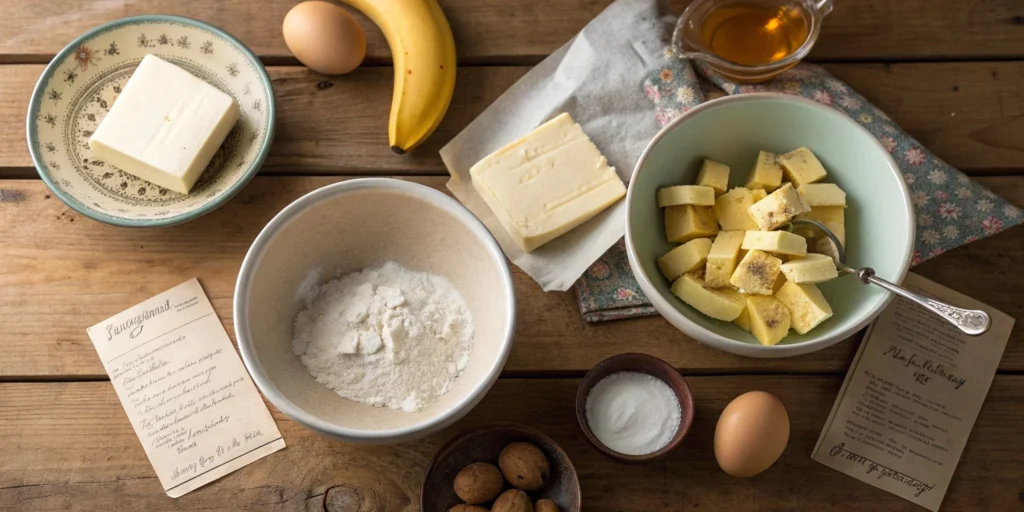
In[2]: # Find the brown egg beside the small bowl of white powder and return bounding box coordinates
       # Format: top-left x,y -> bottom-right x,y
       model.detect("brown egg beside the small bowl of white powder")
715,391 -> 790,477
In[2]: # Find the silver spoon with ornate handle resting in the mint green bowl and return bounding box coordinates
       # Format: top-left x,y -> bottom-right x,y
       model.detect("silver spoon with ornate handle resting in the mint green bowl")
790,219 -> 992,336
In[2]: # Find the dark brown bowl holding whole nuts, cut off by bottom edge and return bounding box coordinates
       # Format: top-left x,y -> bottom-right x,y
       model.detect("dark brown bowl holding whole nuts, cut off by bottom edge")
420,423 -> 580,512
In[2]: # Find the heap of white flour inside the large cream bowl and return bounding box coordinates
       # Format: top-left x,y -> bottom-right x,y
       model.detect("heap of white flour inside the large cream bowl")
292,262 -> 473,412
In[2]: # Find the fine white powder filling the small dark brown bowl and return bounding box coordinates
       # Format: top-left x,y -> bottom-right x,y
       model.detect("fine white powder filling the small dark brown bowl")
586,372 -> 682,456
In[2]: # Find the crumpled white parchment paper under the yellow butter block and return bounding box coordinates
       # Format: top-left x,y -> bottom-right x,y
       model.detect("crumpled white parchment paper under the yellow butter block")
440,0 -> 673,291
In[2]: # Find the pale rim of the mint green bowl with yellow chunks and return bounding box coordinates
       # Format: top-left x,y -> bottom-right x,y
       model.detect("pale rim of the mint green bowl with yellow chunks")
626,92 -> 916,357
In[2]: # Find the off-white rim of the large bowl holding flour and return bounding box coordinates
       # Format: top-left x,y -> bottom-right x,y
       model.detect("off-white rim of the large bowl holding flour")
232,178 -> 516,442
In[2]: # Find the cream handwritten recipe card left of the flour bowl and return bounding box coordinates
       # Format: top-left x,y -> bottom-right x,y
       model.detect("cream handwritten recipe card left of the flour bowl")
88,279 -> 285,498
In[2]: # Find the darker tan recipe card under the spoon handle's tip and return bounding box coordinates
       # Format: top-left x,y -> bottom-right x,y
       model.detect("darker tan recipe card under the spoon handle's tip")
811,273 -> 1014,511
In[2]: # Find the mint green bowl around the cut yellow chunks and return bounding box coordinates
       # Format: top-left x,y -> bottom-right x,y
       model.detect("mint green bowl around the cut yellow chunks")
626,93 -> 914,357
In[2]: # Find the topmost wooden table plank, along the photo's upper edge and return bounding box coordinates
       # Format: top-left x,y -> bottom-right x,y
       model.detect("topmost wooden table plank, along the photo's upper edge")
0,0 -> 1024,62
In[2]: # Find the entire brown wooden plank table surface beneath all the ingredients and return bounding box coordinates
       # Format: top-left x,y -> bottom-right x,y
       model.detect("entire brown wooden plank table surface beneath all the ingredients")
0,0 -> 1024,512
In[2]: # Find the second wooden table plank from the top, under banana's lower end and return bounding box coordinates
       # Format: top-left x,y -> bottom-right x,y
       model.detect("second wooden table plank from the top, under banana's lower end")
6,61 -> 1024,177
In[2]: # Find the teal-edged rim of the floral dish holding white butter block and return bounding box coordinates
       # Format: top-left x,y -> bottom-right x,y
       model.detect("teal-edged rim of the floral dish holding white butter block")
26,14 -> 278,227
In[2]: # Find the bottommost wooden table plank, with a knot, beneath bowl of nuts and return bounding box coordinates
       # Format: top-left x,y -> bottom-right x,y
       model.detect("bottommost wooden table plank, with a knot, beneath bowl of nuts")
0,376 -> 1024,512
